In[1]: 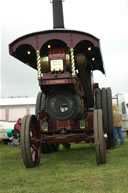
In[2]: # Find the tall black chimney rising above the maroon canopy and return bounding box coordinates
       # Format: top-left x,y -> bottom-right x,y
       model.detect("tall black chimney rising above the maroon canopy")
51,0 -> 64,29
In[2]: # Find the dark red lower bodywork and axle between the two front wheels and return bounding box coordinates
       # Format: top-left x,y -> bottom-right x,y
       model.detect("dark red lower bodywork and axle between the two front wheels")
34,112 -> 94,144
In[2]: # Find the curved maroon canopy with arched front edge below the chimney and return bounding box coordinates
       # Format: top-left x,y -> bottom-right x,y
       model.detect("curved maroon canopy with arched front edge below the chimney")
9,29 -> 105,73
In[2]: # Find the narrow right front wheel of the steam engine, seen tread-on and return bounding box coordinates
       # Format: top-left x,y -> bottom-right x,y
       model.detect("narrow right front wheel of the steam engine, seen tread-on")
93,109 -> 106,164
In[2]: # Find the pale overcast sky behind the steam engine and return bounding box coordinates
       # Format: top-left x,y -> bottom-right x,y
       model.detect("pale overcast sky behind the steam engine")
0,0 -> 128,97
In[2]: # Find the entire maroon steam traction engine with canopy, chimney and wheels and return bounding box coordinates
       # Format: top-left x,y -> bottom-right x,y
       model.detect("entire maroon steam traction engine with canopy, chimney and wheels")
9,0 -> 114,168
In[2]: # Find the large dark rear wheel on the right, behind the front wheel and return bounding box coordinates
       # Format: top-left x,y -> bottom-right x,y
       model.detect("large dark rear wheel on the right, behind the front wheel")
95,88 -> 115,149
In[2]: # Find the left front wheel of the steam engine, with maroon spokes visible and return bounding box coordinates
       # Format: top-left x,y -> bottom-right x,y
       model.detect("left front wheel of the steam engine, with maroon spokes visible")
21,115 -> 40,168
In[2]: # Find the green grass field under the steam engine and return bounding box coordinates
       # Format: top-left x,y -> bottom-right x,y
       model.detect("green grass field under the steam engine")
0,139 -> 128,193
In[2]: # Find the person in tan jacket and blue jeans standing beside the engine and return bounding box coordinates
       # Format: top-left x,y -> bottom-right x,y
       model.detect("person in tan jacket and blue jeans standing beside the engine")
113,104 -> 124,145
